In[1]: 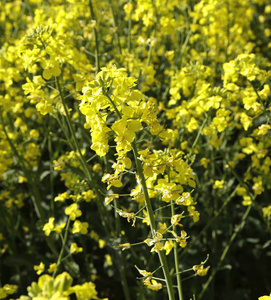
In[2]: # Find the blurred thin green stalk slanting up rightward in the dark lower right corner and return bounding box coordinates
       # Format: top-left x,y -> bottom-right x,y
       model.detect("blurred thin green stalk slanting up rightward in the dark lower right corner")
198,205 -> 251,300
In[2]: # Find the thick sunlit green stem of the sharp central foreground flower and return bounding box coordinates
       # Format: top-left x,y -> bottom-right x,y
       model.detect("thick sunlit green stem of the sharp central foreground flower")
132,142 -> 175,300
